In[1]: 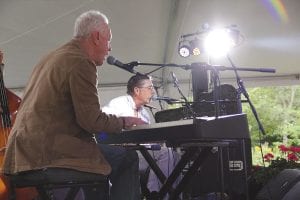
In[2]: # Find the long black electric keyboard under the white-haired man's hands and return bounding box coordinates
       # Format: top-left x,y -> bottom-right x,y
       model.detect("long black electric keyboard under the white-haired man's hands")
100,114 -> 250,144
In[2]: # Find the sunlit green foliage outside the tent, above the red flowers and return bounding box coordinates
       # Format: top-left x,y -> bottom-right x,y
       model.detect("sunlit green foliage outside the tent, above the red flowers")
243,86 -> 300,145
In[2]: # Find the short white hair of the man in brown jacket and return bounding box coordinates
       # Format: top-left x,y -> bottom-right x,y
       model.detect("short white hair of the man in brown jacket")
73,10 -> 108,38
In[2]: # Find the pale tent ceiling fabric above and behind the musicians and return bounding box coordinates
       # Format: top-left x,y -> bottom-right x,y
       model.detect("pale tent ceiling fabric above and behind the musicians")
0,0 -> 300,88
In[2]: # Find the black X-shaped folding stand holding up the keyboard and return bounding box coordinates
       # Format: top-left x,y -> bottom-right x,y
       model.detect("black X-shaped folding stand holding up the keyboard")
138,141 -> 229,200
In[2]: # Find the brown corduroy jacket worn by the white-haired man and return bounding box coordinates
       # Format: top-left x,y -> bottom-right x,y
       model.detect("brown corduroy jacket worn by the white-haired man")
2,40 -> 123,175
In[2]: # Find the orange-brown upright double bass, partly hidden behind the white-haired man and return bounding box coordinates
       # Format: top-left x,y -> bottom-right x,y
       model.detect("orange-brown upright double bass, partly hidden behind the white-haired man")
0,51 -> 37,200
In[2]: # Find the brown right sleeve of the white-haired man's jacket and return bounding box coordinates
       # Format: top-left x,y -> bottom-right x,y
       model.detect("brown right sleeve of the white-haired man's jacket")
69,61 -> 123,133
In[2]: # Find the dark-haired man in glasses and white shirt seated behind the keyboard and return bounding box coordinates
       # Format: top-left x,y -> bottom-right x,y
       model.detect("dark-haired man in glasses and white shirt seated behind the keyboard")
102,74 -> 179,197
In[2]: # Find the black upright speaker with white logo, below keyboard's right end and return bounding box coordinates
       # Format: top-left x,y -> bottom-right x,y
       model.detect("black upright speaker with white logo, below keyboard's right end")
186,139 -> 252,200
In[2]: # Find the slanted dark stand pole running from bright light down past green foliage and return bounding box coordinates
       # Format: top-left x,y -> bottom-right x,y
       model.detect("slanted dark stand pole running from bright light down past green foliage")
227,55 -> 266,135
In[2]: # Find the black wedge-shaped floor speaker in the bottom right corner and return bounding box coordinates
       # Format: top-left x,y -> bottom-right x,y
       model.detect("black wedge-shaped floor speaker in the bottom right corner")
256,169 -> 300,200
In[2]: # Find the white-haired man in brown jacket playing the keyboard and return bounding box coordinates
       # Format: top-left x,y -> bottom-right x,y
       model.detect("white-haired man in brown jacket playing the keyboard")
2,10 -> 144,200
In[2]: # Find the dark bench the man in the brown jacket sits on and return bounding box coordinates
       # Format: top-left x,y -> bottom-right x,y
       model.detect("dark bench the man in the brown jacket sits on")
5,168 -> 109,200
